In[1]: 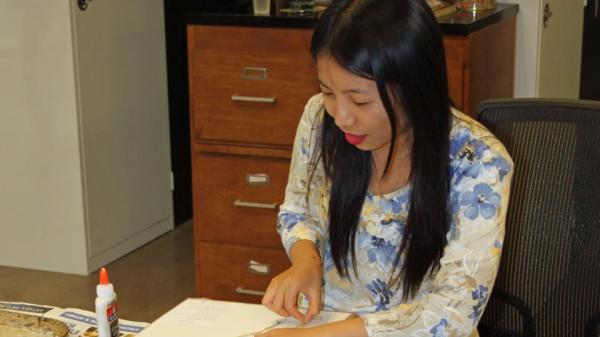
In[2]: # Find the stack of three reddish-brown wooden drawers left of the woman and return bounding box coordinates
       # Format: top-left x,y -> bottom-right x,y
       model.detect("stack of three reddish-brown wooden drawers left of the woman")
188,25 -> 318,303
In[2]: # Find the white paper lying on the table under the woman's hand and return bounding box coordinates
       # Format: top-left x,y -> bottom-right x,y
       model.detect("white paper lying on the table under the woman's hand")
137,298 -> 350,337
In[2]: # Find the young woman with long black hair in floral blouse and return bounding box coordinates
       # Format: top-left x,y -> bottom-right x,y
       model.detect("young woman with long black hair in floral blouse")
263,0 -> 512,337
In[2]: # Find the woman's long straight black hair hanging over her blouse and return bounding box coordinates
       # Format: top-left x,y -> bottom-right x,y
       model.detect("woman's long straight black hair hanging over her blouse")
311,0 -> 451,300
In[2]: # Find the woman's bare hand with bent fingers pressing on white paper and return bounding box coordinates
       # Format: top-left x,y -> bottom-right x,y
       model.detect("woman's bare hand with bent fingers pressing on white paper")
262,240 -> 323,322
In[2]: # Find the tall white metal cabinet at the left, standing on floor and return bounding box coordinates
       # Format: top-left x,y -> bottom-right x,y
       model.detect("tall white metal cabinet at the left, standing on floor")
0,0 -> 173,274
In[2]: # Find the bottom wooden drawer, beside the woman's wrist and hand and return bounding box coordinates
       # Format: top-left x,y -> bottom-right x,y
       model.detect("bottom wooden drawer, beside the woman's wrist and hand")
196,242 -> 290,303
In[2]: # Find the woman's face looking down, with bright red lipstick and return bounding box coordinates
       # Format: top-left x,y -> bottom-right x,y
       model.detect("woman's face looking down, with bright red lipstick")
317,56 -> 405,157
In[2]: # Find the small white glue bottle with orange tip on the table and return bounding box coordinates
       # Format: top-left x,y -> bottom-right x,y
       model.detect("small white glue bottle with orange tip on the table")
96,268 -> 119,337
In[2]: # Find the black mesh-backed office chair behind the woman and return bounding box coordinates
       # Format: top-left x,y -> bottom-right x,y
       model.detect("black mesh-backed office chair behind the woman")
477,99 -> 600,337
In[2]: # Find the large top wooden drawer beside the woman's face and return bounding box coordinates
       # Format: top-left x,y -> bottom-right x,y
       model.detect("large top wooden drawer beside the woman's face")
188,26 -> 318,146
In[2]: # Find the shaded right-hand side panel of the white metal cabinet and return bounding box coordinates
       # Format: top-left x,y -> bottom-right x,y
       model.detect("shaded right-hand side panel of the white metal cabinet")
71,0 -> 173,262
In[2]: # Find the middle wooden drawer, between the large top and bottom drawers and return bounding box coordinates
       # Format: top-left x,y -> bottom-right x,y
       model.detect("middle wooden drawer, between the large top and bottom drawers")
193,152 -> 289,248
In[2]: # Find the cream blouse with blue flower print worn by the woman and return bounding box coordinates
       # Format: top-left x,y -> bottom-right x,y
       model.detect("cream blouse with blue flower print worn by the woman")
277,94 -> 513,337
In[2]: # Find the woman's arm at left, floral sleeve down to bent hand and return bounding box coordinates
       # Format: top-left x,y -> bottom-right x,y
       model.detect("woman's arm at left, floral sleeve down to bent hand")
262,95 -> 327,321
